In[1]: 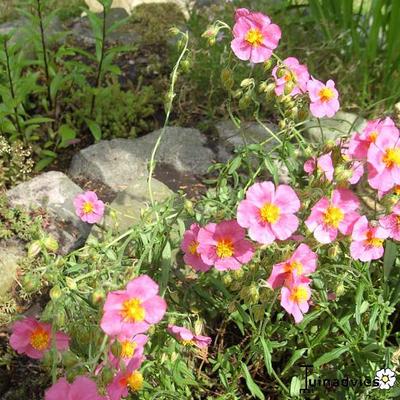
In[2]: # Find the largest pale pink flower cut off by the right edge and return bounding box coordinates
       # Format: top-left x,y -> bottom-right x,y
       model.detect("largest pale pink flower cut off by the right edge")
367,125 -> 400,192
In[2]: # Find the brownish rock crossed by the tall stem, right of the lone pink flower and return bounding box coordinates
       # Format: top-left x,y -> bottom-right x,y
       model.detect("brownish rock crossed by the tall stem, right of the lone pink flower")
91,177 -> 174,239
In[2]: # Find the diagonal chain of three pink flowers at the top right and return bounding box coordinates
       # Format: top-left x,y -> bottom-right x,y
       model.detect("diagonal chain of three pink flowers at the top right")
231,8 -> 339,118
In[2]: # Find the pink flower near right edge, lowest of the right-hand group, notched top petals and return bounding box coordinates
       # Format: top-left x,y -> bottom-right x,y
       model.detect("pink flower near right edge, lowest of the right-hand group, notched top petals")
350,216 -> 389,262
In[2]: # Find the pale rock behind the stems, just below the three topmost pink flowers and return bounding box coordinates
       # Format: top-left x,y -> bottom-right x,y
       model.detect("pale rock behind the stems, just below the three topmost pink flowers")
304,111 -> 367,143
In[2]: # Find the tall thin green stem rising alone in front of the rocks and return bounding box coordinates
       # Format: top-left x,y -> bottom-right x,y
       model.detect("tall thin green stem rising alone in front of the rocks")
148,33 -> 189,208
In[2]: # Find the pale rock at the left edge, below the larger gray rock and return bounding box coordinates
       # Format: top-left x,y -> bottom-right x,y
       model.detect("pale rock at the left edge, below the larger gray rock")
0,240 -> 25,299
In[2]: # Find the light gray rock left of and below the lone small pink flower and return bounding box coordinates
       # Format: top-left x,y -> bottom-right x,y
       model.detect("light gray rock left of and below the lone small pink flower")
7,171 -> 91,254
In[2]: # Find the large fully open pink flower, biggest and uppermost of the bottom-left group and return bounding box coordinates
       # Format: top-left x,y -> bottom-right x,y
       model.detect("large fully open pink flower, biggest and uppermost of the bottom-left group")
100,275 -> 167,337
